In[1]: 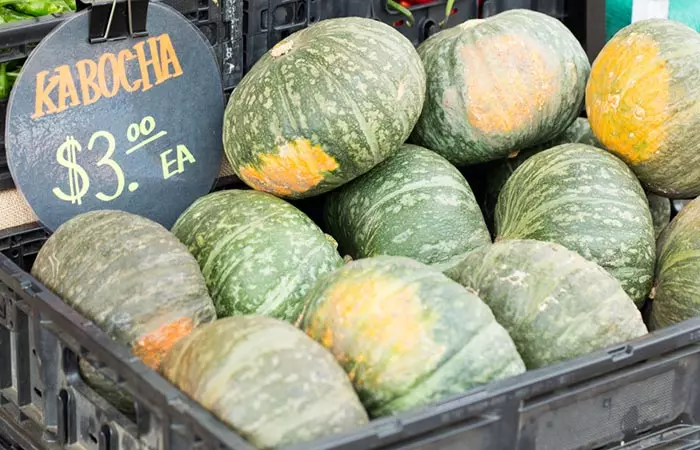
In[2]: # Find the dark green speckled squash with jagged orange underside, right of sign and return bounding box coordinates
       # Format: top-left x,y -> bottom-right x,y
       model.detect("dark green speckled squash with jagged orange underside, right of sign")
223,17 -> 425,198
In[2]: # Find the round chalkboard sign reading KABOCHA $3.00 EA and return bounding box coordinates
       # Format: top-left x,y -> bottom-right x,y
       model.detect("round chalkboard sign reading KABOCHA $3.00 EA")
5,3 -> 224,230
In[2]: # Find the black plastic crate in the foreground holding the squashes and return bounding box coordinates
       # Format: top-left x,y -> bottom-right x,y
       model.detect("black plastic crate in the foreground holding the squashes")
0,222 -> 700,450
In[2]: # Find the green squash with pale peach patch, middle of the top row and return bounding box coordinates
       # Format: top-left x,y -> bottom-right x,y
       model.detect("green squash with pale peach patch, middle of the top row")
411,10 -> 590,165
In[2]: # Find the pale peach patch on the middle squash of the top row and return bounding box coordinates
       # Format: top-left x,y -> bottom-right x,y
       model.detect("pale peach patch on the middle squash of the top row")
459,34 -> 559,134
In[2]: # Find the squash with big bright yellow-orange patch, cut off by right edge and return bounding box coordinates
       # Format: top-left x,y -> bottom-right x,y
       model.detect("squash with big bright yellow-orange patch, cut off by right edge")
586,19 -> 700,198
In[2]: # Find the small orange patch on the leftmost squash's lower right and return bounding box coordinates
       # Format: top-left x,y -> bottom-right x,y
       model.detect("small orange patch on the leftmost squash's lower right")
131,317 -> 194,370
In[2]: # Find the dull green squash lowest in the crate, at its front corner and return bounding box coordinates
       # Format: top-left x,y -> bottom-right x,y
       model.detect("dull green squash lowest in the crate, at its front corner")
161,316 -> 368,449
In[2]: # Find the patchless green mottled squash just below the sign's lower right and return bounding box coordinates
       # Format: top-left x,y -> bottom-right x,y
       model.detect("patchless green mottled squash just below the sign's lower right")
173,190 -> 343,323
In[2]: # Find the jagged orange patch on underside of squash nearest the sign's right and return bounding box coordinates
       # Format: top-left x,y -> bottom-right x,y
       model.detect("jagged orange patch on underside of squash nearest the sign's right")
239,139 -> 339,197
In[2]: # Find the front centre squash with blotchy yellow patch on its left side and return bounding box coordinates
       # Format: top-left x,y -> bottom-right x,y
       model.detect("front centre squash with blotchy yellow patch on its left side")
302,256 -> 525,417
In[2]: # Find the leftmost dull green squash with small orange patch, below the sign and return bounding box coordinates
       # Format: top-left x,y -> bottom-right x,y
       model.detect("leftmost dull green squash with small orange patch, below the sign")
32,210 -> 215,412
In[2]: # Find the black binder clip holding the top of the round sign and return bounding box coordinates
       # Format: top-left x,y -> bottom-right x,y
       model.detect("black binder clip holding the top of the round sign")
76,0 -> 149,44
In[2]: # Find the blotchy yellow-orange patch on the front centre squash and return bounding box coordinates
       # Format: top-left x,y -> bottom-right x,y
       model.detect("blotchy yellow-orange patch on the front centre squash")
306,274 -> 446,387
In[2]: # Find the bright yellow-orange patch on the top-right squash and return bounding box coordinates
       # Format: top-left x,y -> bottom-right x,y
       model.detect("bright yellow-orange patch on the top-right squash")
586,33 -> 671,164
